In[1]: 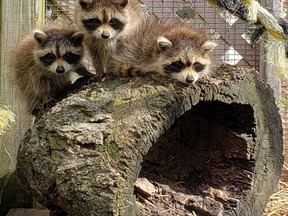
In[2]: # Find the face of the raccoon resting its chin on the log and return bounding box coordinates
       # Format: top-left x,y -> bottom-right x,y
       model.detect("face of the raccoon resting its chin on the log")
157,37 -> 216,84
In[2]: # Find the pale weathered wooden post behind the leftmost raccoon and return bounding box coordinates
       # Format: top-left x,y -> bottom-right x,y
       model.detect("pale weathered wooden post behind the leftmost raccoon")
0,0 -> 45,215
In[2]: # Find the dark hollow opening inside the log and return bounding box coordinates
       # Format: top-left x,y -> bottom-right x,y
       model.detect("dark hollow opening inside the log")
136,101 -> 255,215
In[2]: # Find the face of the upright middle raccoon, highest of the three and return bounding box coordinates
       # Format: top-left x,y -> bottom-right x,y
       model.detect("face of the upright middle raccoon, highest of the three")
80,0 -> 128,40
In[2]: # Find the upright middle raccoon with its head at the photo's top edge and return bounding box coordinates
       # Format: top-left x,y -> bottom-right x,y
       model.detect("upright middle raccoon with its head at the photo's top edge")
76,0 -> 145,75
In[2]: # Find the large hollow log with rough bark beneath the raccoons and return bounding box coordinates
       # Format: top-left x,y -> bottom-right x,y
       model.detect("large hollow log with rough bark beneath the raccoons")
17,66 -> 283,216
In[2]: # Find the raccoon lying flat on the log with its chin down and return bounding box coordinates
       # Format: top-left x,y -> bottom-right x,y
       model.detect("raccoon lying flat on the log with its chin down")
109,20 -> 216,84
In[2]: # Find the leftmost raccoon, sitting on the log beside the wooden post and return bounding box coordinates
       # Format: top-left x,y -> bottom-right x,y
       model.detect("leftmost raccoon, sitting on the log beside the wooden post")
12,24 -> 93,114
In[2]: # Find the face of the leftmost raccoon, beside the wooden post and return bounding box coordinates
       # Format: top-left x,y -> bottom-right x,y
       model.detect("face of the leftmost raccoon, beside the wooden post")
34,30 -> 84,74
